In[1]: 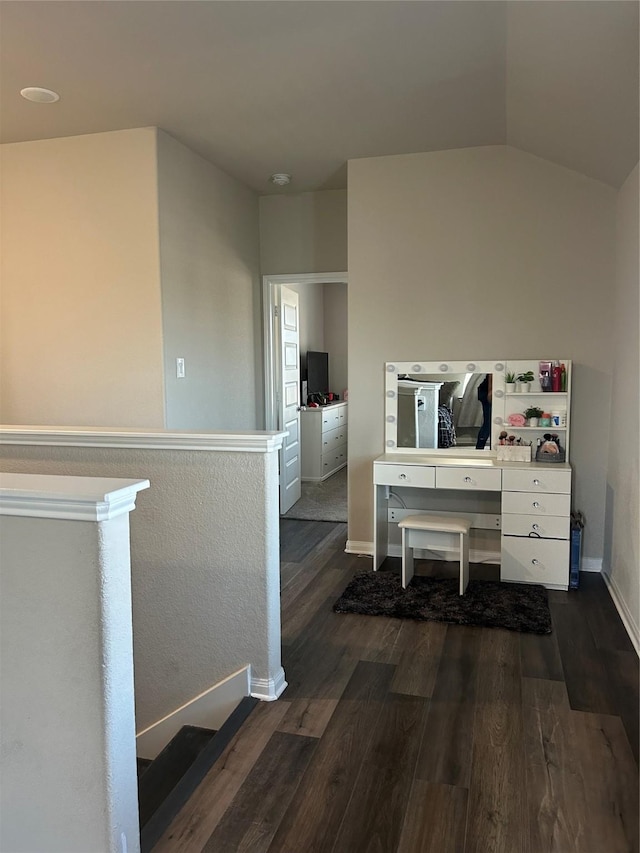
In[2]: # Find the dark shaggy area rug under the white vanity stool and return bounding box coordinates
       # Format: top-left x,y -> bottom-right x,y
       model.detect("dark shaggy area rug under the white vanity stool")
333,571 -> 551,634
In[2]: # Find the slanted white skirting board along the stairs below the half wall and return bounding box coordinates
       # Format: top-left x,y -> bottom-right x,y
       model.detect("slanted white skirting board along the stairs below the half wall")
136,666 -> 251,758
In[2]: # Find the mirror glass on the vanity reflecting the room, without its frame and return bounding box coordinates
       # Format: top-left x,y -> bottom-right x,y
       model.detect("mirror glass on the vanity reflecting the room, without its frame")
398,373 -> 492,450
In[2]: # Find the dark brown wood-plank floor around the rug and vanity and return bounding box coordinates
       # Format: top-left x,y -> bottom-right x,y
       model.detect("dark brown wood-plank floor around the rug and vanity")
155,519 -> 638,853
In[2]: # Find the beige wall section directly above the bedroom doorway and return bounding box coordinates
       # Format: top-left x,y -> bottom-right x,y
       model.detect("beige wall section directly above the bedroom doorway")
260,190 -> 347,275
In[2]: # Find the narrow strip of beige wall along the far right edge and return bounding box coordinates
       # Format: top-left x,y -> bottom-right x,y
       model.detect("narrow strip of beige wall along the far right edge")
604,166 -> 640,637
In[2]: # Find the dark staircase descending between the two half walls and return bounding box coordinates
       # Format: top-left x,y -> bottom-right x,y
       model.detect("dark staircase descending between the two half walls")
138,697 -> 258,853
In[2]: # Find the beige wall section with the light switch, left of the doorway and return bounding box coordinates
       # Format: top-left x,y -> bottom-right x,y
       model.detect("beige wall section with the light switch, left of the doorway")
158,131 -> 264,430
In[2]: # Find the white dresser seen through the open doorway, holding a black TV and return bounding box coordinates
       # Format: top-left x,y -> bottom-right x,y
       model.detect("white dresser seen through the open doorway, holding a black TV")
300,403 -> 348,481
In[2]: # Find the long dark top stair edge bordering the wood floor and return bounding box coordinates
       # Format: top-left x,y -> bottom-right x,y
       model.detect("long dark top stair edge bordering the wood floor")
140,696 -> 260,853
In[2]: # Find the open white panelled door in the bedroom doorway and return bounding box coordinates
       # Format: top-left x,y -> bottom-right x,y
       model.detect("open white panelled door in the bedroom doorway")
278,287 -> 301,514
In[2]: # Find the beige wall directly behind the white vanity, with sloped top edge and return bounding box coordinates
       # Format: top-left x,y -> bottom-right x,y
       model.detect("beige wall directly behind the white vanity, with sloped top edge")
348,146 -> 615,560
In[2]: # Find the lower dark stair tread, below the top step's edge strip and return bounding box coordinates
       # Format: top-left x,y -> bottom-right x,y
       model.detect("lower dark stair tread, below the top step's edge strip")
138,726 -> 215,827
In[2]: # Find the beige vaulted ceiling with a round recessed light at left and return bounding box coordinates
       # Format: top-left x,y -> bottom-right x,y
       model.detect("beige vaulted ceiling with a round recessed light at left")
0,0 -> 639,193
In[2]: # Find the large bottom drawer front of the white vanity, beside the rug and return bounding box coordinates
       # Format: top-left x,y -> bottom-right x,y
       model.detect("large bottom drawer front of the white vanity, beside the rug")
500,536 -> 569,586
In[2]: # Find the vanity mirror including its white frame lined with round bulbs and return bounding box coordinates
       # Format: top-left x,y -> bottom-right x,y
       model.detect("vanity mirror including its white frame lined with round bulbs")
384,361 -> 505,455
